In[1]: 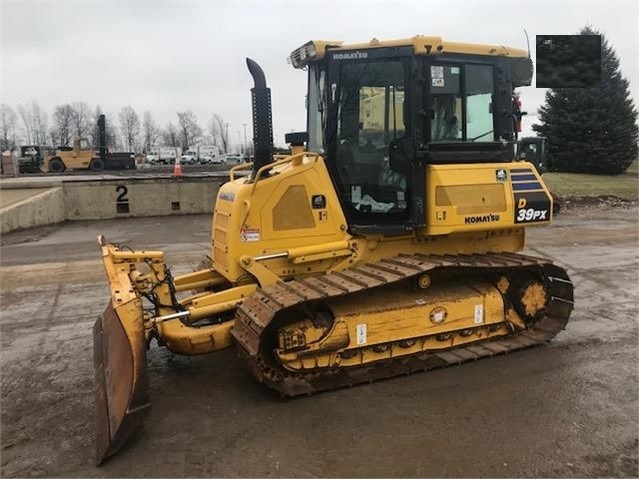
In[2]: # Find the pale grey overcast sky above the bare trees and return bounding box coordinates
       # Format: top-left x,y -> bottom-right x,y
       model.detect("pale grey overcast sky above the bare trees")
0,0 -> 639,150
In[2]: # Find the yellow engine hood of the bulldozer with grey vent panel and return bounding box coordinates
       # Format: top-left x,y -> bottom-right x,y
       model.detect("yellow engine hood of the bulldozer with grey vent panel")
212,157 -> 350,282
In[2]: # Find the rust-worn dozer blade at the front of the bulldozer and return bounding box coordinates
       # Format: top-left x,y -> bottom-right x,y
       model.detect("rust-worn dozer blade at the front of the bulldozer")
93,299 -> 151,465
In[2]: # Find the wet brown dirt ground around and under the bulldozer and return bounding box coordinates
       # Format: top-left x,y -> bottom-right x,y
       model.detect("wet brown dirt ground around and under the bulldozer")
0,204 -> 639,477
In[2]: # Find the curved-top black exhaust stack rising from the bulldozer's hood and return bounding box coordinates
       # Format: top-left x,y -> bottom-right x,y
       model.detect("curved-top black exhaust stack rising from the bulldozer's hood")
246,58 -> 273,180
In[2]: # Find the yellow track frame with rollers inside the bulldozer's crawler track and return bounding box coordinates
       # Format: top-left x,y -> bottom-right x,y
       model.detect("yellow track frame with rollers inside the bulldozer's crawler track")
278,281 -> 505,370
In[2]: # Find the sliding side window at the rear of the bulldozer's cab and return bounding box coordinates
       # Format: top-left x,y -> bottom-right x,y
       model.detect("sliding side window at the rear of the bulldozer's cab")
430,64 -> 495,142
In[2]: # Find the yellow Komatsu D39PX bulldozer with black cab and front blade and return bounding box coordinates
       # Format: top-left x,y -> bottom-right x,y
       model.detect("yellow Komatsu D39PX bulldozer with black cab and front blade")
94,36 -> 573,462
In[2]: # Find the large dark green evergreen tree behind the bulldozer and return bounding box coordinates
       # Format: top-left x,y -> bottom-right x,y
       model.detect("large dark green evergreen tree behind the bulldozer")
532,26 -> 638,175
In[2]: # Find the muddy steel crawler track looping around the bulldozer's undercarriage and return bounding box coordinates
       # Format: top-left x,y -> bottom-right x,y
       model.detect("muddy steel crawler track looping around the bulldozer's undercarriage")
231,253 -> 574,396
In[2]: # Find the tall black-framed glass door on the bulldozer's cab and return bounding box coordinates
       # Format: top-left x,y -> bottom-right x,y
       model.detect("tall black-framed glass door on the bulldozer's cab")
327,55 -> 413,234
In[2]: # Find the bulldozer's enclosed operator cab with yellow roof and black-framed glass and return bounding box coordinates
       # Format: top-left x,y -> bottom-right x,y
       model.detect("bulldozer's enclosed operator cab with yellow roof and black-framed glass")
291,37 -> 532,234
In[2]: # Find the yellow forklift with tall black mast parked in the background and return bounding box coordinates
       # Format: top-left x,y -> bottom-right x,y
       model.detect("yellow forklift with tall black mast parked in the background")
40,115 -> 136,173
